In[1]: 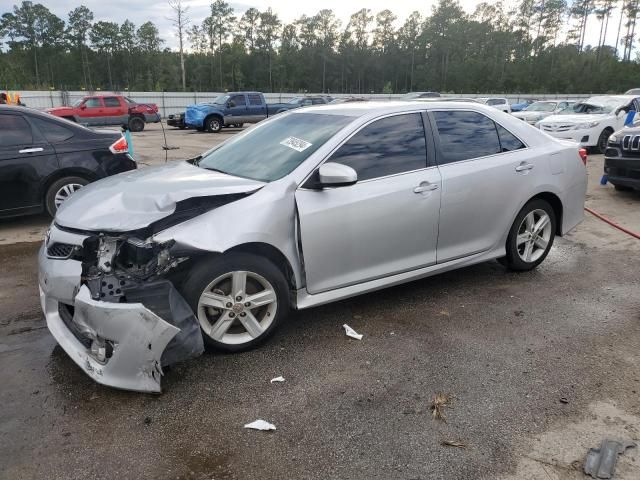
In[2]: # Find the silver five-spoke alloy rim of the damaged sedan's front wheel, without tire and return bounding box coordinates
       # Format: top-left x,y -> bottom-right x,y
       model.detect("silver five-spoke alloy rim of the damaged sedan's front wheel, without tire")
198,271 -> 278,345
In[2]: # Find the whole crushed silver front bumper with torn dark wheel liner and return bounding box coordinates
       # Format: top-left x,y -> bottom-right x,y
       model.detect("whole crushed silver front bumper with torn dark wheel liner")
38,226 -> 204,393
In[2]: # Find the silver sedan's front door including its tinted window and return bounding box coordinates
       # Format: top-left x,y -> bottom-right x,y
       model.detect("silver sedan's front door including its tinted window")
296,112 -> 441,294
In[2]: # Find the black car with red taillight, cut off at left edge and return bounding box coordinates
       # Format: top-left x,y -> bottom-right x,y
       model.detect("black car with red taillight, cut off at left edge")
0,105 -> 136,217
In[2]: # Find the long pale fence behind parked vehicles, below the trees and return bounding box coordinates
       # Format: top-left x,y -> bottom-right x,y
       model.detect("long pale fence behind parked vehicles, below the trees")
13,90 -> 591,117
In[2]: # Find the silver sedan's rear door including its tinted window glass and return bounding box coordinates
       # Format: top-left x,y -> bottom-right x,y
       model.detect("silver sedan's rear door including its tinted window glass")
430,110 -> 546,263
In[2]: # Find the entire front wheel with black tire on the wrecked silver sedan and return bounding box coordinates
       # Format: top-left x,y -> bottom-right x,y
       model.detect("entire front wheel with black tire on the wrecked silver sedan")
183,253 -> 289,352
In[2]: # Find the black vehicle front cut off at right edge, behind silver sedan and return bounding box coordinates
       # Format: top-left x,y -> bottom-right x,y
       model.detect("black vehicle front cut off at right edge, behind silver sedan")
604,124 -> 640,191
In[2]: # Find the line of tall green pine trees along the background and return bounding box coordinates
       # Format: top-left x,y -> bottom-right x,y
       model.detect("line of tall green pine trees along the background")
0,0 -> 640,94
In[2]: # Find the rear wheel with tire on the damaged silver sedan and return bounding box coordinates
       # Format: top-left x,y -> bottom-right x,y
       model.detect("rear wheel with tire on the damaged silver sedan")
501,199 -> 556,271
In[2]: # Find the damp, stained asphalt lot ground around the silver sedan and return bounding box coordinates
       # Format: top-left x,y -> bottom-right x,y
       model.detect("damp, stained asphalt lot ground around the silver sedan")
0,126 -> 640,480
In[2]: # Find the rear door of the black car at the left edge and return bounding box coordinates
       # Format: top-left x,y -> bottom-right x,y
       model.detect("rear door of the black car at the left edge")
0,112 -> 58,215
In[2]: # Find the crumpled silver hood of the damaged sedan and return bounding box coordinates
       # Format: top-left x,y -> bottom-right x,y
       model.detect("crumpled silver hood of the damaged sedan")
56,161 -> 265,232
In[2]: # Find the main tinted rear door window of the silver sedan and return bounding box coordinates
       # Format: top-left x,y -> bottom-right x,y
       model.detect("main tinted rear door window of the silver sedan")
433,111 -> 500,164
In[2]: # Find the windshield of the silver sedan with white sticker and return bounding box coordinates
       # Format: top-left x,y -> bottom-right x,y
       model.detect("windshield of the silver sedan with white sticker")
197,113 -> 353,182
